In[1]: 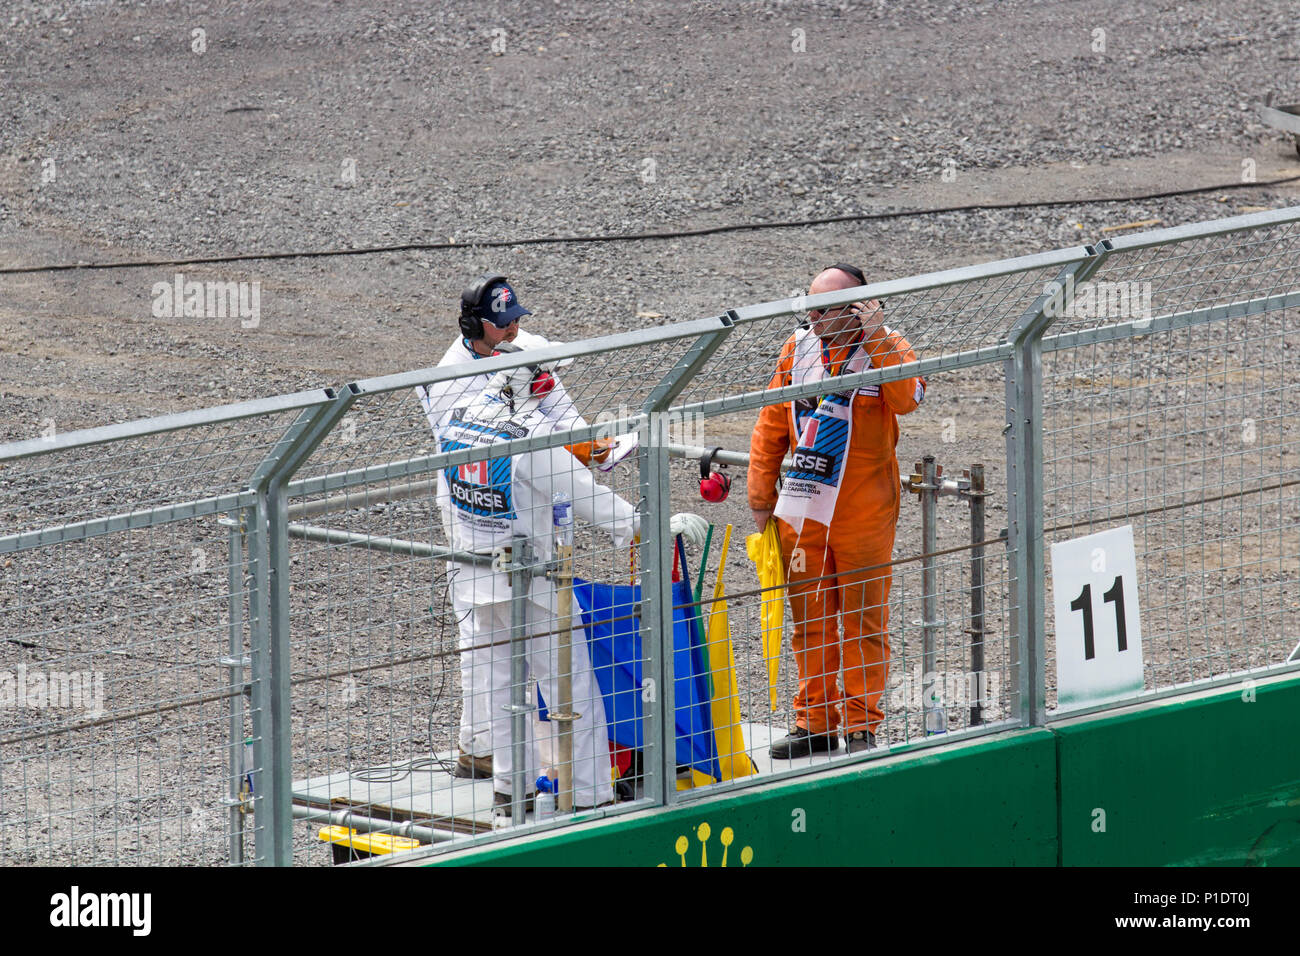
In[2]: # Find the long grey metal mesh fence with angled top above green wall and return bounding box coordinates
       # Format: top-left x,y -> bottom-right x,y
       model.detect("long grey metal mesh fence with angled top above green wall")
0,208 -> 1300,864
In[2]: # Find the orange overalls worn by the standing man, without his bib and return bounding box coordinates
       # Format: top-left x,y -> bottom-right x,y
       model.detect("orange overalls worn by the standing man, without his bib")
748,328 -> 926,735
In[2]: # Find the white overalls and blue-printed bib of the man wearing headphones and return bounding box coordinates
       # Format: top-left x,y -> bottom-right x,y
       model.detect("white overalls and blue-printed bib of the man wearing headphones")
438,353 -> 705,809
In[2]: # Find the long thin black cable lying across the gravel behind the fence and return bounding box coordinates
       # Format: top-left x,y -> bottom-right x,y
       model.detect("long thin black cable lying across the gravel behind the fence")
0,176 -> 1300,276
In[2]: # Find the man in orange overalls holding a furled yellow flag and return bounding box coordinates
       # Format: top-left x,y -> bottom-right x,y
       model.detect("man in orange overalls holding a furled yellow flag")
748,265 -> 926,760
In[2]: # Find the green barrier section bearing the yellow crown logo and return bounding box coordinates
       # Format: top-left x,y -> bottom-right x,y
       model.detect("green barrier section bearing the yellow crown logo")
421,730 -> 1057,866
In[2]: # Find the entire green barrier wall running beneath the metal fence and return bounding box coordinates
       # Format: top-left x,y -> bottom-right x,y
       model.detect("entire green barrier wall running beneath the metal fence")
416,678 -> 1300,866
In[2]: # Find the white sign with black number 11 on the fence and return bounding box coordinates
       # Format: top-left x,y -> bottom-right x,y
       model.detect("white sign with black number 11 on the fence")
1052,524 -> 1143,710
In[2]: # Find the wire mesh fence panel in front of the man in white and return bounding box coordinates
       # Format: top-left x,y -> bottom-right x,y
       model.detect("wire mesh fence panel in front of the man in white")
289,355 -> 676,862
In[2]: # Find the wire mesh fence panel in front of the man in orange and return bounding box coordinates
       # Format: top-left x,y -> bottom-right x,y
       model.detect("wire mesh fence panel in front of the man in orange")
679,340 -> 1019,795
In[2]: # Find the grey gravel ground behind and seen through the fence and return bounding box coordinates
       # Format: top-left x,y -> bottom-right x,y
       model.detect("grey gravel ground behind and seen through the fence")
0,0 -> 1300,864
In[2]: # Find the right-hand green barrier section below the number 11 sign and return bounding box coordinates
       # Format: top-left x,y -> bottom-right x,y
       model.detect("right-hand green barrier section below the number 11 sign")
1052,679 -> 1300,866
